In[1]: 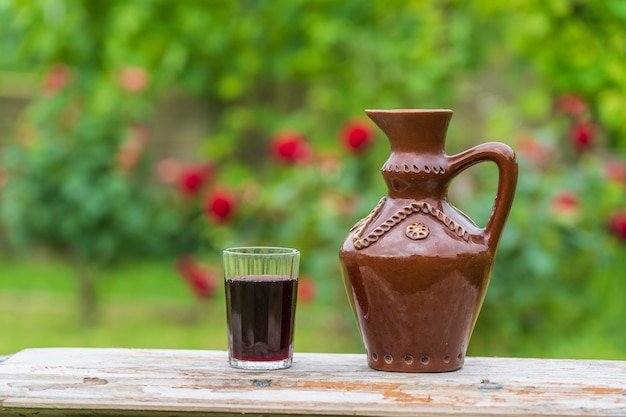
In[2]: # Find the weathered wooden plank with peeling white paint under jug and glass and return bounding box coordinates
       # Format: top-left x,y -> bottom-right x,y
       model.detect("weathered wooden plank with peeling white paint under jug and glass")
0,348 -> 626,417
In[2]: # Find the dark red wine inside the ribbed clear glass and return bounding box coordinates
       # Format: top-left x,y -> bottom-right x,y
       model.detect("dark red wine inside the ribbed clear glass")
226,275 -> 298,362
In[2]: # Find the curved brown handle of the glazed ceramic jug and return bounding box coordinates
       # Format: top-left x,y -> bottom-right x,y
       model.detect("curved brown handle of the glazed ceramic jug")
449,142 -> 517,249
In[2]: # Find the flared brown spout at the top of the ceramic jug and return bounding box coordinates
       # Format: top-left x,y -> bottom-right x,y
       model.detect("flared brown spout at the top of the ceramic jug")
365,109 -> 452,154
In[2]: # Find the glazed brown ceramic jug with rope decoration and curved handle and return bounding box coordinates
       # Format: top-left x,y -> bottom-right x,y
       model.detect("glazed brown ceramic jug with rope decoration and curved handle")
339,110 -> 517,372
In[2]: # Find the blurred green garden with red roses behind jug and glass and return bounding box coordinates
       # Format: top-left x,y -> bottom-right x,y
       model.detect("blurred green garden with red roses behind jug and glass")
0,0 -> 626,359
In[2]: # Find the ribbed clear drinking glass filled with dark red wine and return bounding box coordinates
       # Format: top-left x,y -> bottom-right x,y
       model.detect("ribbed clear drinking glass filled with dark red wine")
223,247 -> 300,370
